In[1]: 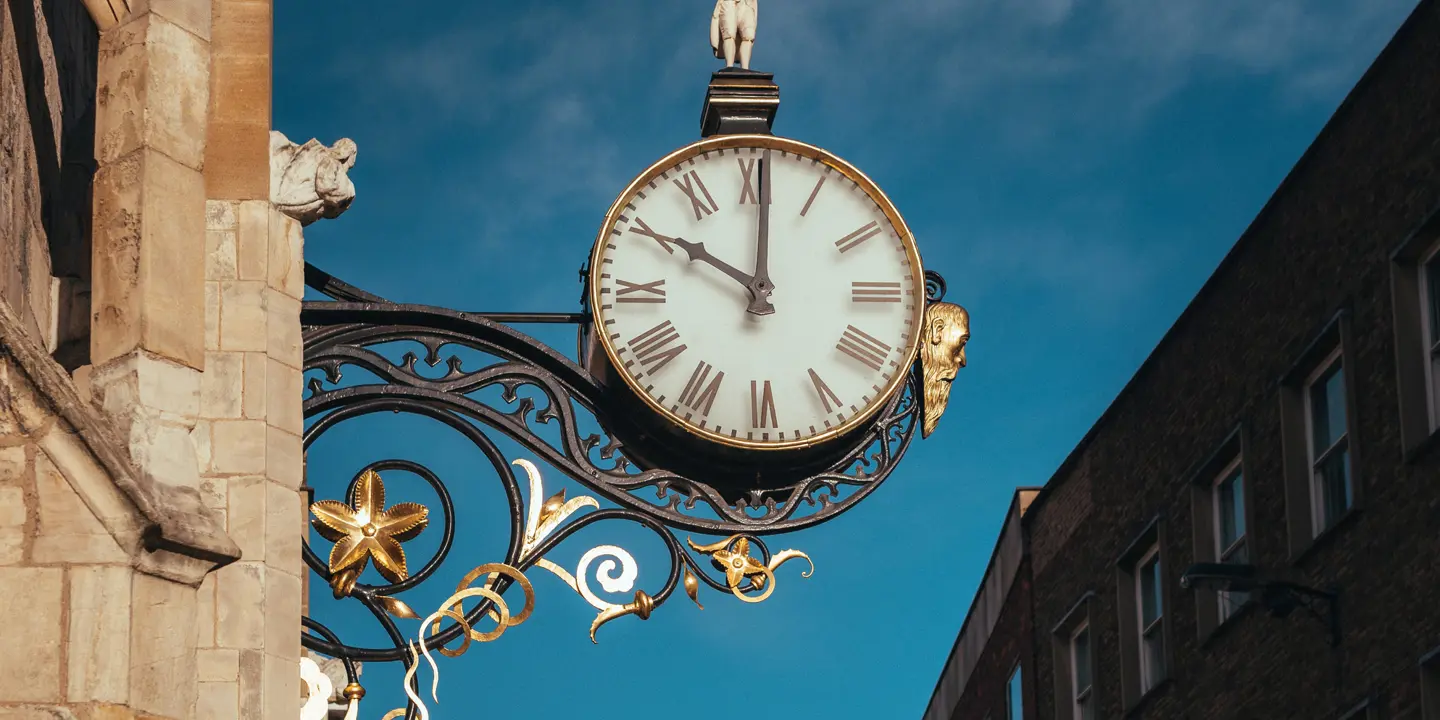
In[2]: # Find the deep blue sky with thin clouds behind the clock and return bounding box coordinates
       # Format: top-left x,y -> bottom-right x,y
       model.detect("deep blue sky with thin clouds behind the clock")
275,0 -> 1414,720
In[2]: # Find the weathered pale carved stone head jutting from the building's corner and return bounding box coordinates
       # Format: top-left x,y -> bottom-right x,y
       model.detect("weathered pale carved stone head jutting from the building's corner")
271,130 -> 357,225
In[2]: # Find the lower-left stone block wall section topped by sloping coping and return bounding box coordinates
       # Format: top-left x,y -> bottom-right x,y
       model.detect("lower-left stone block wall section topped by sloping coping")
0,295 -> 239,720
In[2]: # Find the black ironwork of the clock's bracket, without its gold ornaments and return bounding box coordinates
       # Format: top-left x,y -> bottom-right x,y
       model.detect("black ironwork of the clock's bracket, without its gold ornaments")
301,265 -> 943,685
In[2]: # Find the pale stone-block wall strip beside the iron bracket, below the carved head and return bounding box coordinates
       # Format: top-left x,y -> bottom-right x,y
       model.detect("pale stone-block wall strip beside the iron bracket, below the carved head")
196,200 -> 305,720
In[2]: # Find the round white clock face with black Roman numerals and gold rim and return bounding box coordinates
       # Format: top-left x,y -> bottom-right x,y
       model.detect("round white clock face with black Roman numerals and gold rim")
590,135 -> 924,449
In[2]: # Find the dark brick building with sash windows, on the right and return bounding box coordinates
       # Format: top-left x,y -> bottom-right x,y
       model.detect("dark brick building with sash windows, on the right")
924,0 -> 1440,720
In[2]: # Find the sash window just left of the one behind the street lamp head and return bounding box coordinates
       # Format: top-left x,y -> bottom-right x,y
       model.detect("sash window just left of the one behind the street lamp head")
1117,517 -> 1171,711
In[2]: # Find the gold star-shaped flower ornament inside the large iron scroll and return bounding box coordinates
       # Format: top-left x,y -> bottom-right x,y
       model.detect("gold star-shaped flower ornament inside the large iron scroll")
310,469 -> 431,598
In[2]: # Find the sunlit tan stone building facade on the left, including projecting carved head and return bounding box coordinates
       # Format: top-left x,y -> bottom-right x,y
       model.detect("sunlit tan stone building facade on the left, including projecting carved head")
0,0 -> 354,720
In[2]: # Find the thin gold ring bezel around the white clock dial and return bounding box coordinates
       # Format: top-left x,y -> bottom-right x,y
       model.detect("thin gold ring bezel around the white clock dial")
588,135 -> 926,451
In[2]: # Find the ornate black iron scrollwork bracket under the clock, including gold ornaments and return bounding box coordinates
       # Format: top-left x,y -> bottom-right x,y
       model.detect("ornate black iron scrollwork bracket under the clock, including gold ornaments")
301,265 -> 945,717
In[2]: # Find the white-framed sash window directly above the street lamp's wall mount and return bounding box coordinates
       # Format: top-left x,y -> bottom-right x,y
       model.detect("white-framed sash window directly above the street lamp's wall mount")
1305,348 -> 1355,536
